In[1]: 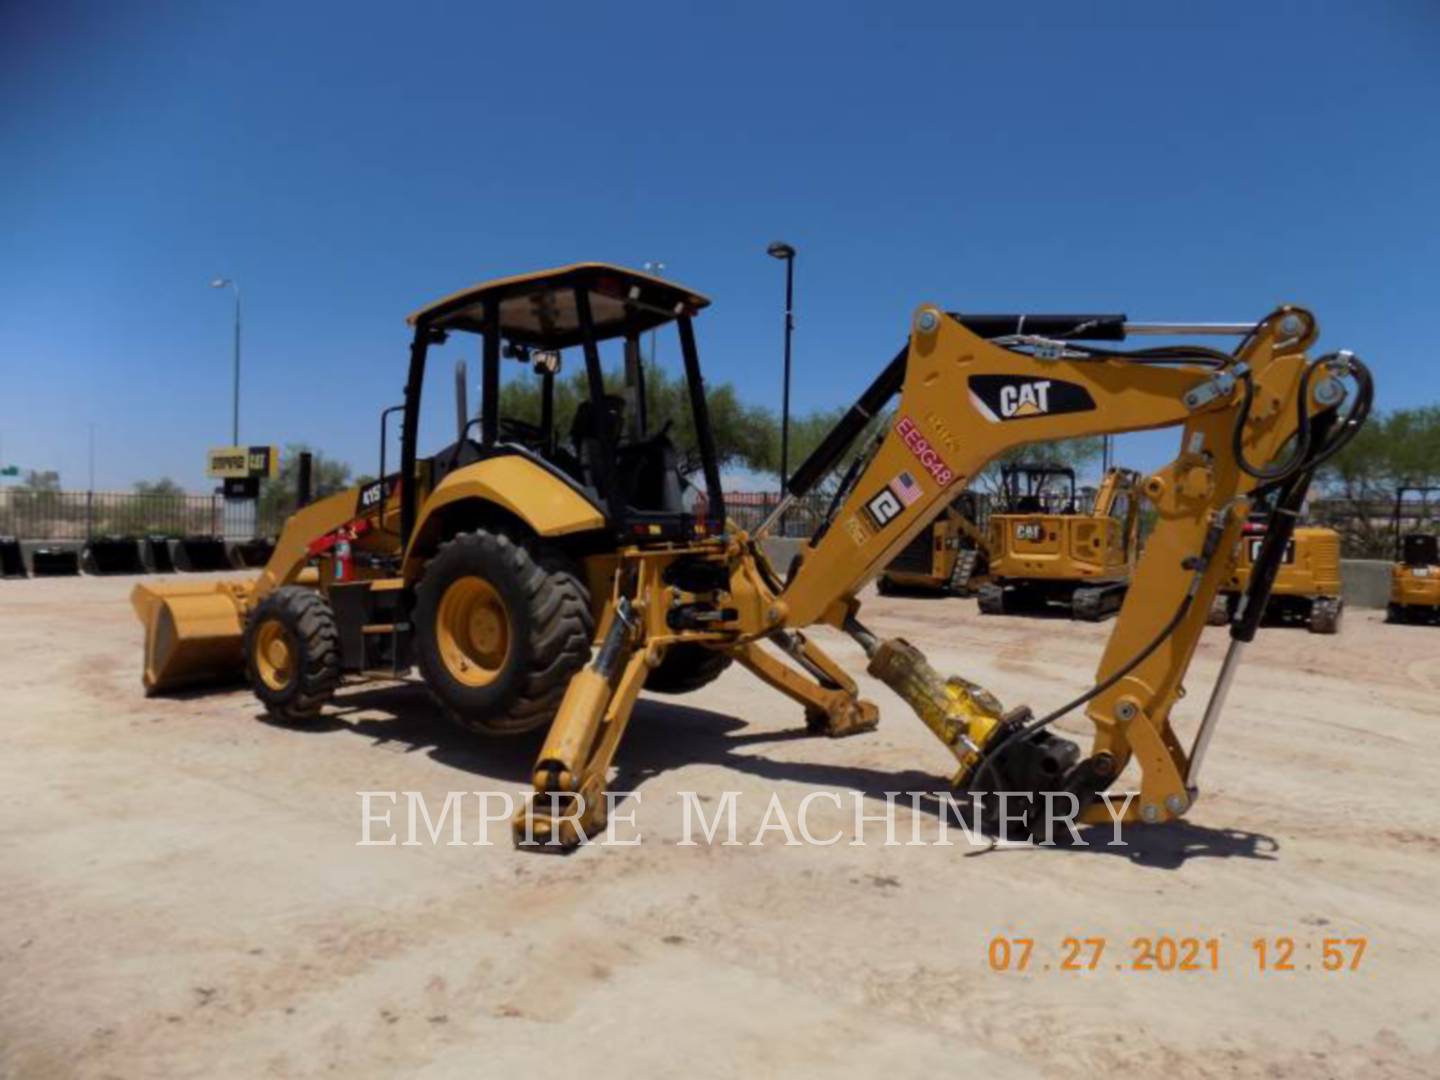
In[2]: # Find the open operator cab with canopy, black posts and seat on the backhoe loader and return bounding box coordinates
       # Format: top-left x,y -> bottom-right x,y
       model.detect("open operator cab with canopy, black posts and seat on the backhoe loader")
402,262 -> 724,543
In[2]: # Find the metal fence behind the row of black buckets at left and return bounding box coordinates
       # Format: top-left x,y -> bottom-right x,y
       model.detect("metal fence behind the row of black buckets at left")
0,488 -> 282,540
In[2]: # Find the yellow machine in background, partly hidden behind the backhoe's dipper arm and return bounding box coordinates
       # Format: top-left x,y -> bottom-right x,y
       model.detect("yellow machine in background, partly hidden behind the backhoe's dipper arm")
1210,517 -> 1345,634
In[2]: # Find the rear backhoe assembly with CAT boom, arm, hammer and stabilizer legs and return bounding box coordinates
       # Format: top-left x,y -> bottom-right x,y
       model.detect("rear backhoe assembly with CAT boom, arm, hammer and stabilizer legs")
517,305 -> 1372,844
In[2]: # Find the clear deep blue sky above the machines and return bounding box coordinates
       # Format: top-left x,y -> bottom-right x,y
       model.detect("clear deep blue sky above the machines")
0,0 -> 1440,490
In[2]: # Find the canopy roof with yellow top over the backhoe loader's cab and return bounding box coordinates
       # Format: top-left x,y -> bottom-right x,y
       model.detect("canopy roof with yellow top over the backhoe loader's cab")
408,262 -> 710,348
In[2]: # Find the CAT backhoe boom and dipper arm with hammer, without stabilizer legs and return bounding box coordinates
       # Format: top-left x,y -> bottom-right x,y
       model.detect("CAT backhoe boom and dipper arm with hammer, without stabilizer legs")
776,305 -> 1368,821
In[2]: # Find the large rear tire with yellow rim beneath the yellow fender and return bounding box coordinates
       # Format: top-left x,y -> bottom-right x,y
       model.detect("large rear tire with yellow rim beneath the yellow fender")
415,530 -> 595,734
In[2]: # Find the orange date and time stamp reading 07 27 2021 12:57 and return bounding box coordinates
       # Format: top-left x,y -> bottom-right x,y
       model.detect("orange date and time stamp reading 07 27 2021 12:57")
985,935 -> 1369,973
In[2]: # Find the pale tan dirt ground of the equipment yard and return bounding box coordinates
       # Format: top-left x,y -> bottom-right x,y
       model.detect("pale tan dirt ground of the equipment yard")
0,579 -> 1440,1077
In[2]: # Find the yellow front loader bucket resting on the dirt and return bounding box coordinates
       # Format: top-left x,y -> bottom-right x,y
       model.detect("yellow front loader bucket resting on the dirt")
130,582 -> 253,694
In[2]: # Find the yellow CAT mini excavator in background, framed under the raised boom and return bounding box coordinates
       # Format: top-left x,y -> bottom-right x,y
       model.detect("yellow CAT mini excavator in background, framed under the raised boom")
978,462 -> 1140,622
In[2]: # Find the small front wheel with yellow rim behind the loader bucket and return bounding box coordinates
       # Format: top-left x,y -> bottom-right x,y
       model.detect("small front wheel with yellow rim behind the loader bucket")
245,585 -> 340,726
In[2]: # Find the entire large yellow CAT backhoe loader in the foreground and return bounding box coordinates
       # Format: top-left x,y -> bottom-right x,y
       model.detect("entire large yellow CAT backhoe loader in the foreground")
135,264 -> 1372,847
